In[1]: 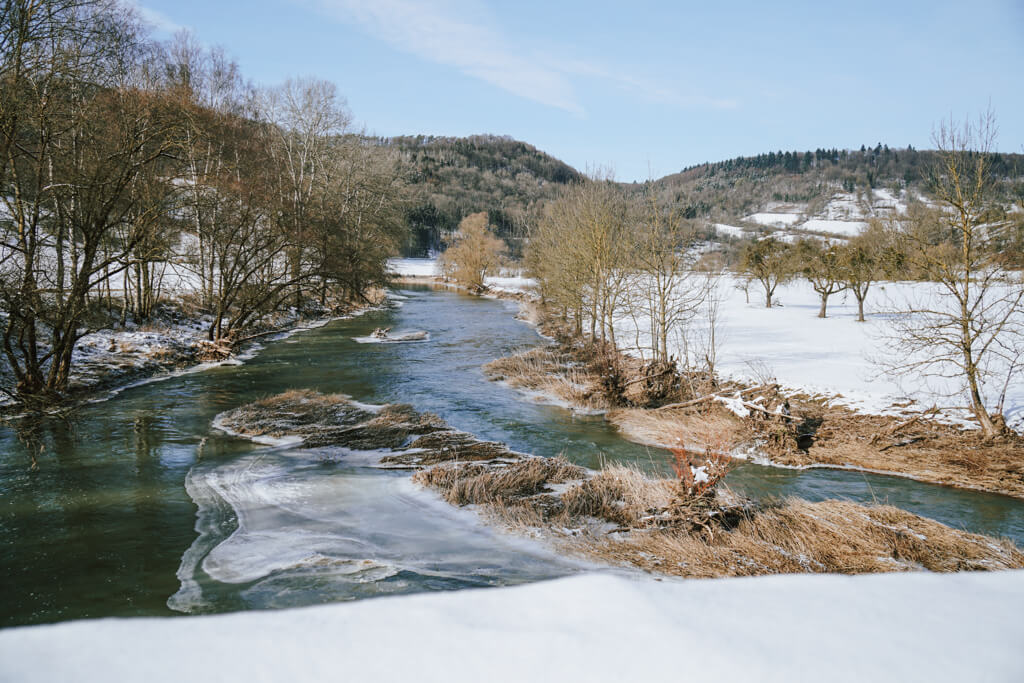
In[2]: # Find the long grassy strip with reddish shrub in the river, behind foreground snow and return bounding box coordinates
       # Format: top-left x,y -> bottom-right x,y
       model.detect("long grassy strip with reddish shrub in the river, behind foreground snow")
215,391 -> 1024,578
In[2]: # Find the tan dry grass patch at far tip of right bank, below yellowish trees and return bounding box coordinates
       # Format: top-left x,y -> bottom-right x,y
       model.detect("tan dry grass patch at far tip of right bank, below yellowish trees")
483,347 -> 608,410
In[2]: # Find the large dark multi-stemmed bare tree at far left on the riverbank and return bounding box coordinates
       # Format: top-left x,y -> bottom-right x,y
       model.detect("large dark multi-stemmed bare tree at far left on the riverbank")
0,2 -> 174,403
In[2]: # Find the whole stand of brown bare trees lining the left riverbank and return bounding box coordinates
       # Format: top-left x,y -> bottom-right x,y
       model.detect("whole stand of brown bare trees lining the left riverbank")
0,0 -> 402,402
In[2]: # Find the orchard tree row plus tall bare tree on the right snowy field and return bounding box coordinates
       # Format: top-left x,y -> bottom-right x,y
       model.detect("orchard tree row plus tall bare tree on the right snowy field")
740,114 -> 1024,436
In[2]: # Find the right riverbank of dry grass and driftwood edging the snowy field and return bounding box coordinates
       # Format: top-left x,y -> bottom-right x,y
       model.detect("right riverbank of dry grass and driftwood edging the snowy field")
484,313 -> 1024,498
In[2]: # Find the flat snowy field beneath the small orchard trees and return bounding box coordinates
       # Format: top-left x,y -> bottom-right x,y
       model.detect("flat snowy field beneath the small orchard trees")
616,278 -> 1024,429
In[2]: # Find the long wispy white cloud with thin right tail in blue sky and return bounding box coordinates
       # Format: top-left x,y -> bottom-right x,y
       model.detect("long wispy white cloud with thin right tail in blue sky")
303,0 -> 736,116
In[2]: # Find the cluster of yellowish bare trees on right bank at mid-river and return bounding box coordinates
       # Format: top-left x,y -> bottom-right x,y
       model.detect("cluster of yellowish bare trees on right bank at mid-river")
525,176 -> 717,370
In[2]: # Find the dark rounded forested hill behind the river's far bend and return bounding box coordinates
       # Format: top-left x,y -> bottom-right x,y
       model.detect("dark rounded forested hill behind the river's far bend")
377,135 -> 582,255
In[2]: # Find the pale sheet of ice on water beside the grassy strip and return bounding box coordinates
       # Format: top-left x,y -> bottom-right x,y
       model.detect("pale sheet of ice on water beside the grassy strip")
168,449 -> 581,612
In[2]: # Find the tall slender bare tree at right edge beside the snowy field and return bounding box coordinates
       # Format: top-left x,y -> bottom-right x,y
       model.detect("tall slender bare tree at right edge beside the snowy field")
889,113 -> 1024,437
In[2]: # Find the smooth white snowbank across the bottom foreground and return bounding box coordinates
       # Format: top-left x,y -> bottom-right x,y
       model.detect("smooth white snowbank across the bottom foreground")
0,571 -> 1024,683
